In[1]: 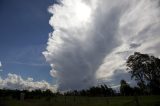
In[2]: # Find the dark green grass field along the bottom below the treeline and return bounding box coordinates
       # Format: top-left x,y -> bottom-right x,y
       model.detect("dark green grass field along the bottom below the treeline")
0,96 -> 160,106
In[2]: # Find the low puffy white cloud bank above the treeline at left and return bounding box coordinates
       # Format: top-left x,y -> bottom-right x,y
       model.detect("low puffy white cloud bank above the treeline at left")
0,73 -> 57,92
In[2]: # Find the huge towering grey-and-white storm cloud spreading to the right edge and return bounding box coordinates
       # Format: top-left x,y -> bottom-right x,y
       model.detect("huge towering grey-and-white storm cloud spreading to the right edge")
43,0 -> 160,90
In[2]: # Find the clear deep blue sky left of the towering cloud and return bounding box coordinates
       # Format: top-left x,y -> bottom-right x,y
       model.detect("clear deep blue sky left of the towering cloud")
0,0 -> 54,83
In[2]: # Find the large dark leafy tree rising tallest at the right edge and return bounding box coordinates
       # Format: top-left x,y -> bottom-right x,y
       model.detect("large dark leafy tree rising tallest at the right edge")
126,52 -> 160,93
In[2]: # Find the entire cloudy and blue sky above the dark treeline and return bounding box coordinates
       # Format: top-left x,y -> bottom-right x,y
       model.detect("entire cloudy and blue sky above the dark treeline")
0,0 -> 160,91
